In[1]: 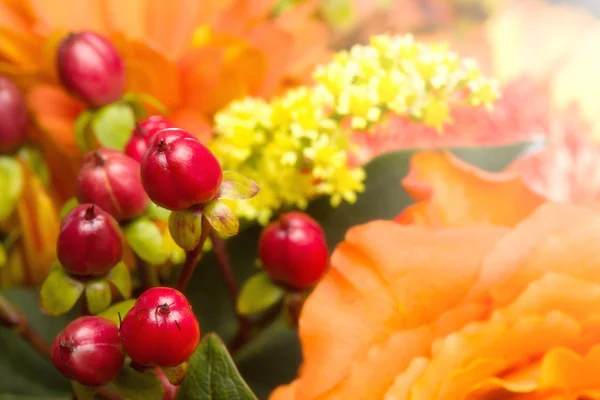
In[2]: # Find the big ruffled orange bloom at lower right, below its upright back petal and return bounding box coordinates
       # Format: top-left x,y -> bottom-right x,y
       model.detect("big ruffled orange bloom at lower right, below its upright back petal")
271,203 -> 600,400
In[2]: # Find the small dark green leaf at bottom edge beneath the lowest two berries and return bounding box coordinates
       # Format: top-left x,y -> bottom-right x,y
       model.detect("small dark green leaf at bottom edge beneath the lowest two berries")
112,366 -> 165,400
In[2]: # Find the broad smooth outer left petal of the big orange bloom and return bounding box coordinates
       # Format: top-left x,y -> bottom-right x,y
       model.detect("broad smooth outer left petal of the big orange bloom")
290,221 -> 506,399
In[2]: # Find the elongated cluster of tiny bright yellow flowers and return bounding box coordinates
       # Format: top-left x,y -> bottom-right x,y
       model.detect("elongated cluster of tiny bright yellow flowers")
210,36 -> 498,224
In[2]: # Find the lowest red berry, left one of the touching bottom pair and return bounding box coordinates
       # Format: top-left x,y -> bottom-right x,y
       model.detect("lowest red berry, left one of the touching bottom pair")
52,317 -> 125,386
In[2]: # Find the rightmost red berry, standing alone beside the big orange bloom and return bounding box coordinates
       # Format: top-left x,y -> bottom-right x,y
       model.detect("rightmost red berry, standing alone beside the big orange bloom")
258,212 -> 329,290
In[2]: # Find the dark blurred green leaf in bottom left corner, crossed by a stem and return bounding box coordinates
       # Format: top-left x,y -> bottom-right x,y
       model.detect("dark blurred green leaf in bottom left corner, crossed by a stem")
0,288 -> 76,394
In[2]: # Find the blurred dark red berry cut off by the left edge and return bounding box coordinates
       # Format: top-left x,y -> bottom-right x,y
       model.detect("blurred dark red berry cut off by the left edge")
0,76 -> 27,153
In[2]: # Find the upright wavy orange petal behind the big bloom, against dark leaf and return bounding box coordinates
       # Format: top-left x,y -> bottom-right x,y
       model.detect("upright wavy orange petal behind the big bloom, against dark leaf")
396,151 -> 543,227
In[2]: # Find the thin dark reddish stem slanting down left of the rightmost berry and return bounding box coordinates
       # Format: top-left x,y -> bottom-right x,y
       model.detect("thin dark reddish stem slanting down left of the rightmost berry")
210,229 -> 252,347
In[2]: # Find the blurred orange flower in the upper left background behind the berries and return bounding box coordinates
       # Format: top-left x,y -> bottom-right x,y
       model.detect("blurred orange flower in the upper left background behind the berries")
0,0 -> 328,199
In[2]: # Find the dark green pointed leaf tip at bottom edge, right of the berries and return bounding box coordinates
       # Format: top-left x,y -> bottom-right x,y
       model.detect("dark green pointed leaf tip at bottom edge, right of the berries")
177,333 -> 257,400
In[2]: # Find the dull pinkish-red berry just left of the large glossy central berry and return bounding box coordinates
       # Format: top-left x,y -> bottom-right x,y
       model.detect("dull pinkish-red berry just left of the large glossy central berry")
77,149 -> 150,221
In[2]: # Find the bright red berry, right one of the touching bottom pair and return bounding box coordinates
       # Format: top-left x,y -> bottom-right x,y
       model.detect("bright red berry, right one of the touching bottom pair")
121,287 -> 200,367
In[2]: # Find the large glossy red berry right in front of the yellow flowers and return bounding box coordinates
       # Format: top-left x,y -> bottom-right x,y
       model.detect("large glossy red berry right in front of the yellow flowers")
142,128 -> 223,211
